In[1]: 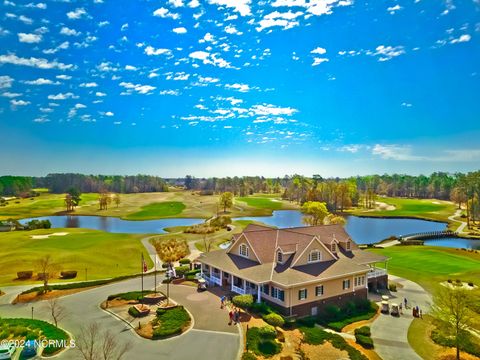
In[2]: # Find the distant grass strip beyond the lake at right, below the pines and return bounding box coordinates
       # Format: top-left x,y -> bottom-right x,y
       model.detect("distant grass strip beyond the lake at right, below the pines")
351,197 -> 456,222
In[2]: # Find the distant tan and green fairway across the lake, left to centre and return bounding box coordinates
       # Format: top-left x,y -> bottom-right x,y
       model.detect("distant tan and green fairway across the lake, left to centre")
0,191 -> 298,220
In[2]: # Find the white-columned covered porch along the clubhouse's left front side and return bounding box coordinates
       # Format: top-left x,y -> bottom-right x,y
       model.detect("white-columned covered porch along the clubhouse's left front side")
200,263 -> 262,303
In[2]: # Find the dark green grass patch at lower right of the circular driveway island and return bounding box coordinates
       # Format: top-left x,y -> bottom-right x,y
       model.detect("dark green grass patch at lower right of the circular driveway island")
153,306 -> 191,339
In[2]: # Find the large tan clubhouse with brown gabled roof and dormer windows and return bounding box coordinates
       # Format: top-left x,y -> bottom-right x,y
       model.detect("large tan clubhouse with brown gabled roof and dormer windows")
197,225 -> 388,316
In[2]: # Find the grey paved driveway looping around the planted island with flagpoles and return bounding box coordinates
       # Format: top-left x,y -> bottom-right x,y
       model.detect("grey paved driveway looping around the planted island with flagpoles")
0,276 -> 240,360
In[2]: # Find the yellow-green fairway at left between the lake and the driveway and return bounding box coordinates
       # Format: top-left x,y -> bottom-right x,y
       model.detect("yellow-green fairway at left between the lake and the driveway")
0,229 -> 152,285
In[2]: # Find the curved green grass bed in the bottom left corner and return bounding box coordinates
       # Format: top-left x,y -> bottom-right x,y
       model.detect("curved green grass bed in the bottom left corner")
0,319 -> 70,355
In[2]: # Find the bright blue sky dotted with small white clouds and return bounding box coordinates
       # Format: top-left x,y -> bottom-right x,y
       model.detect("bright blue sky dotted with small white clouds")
0,0 -> 480,177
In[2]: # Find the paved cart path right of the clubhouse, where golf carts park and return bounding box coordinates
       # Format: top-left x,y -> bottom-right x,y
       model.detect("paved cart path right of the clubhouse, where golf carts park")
371,275 -> 432,360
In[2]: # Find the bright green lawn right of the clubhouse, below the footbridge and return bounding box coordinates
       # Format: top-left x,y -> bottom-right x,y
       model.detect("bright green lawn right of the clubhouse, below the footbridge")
368,246 -> 480,292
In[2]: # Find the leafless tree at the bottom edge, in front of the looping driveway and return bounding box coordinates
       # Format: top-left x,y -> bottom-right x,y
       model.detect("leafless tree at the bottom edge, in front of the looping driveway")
75,323 -> 131,360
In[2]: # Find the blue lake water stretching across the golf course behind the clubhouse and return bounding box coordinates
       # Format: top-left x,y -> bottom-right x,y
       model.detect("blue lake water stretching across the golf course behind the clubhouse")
21,210 -> 480,249
